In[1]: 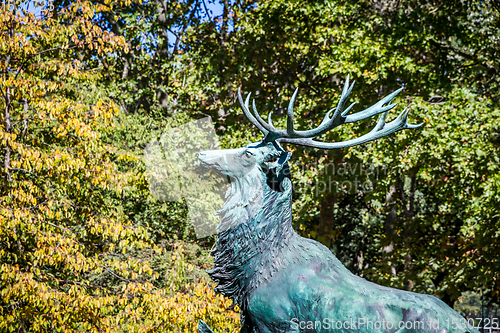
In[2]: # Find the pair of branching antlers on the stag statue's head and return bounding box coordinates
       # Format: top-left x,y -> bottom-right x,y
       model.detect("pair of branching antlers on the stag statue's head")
238,75 -> 422,149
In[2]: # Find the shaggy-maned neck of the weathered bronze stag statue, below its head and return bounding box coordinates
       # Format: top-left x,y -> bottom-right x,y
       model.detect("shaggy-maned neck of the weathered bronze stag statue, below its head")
205,179 -> 301,308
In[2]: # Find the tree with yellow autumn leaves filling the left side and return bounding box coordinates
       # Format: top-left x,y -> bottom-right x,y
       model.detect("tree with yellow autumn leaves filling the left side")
0,1 -> 240,332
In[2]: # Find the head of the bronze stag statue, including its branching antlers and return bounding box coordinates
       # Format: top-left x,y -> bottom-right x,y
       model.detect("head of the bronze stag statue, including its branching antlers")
199,76 -> 422,195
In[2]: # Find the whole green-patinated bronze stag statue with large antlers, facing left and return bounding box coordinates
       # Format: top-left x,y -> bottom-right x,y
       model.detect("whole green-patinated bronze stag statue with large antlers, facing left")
198,77 -> 478,333
